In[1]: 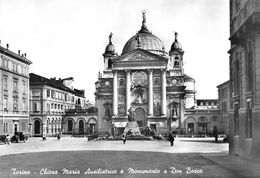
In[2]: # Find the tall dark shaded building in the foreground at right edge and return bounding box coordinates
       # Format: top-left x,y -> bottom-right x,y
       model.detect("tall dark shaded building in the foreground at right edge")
229,0 -> 260,161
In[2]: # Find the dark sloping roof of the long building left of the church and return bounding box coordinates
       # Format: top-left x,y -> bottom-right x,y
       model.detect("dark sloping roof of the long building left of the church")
30,73 -> 85,97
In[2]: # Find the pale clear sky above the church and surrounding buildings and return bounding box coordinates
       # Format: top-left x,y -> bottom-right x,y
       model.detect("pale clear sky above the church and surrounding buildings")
0,0 -> 230,101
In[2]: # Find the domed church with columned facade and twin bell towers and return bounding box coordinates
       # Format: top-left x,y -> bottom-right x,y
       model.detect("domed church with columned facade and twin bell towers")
95,12 -> 195,133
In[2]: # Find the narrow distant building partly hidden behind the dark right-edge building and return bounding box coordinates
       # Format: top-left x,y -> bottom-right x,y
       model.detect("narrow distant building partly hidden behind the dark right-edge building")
217,81 -> 230,135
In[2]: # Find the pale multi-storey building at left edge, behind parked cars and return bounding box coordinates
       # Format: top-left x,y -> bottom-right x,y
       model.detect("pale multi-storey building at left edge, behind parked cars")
0,45 -> 31,136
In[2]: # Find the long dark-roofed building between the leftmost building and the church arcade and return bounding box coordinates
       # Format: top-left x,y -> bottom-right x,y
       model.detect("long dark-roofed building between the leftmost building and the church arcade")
30,73 -> 96,136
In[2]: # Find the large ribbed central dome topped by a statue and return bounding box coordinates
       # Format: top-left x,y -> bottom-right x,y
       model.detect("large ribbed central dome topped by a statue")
122,12 -> 167,55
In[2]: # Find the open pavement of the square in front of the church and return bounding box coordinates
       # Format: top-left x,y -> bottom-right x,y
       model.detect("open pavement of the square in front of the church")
0,137 -> 260,178
